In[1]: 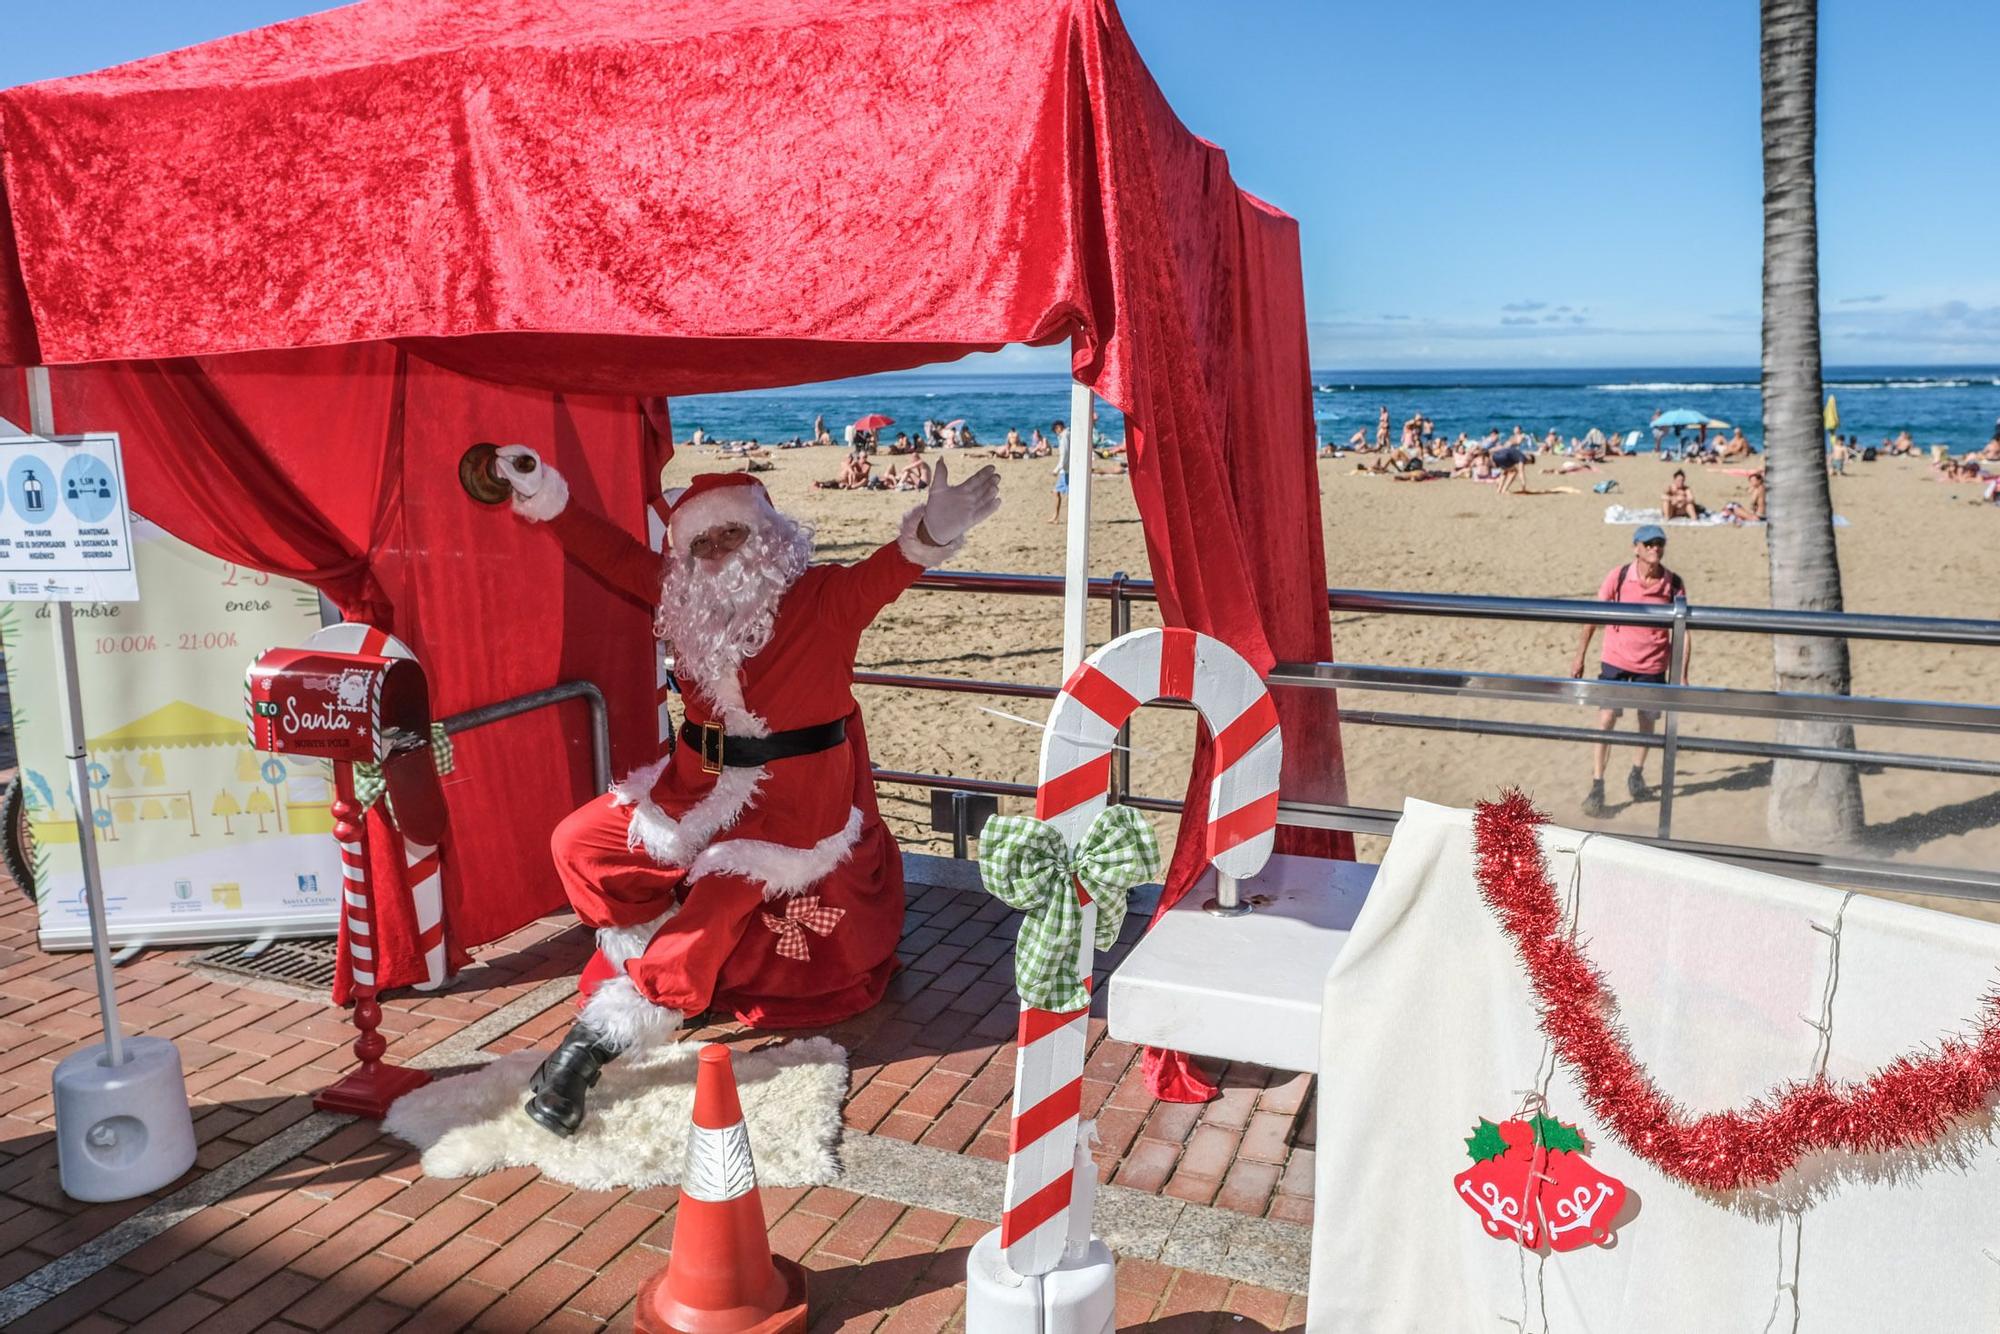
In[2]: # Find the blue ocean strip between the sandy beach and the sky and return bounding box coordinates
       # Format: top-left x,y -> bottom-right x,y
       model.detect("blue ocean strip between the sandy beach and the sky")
672,366 -> 2000,450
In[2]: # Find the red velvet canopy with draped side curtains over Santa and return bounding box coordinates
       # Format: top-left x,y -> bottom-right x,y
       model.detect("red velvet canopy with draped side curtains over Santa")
0,0 -> 1340,1096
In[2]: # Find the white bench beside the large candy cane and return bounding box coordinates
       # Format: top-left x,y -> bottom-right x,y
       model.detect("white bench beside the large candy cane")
1106,854 -> 1376,1074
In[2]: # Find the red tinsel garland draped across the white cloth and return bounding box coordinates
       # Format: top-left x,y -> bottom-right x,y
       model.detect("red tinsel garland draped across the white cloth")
1474,790 -> 2000,1190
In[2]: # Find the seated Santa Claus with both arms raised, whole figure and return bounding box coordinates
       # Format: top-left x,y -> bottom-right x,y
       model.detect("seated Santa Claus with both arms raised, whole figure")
494,446 -> 1000,1136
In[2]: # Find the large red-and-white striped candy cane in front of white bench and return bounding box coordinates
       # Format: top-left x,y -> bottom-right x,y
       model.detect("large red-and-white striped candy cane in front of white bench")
1000,630 -> 1284,1274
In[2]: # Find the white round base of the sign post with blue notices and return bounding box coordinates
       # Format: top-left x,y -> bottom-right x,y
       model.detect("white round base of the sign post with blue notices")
54,1036 -> 194,1202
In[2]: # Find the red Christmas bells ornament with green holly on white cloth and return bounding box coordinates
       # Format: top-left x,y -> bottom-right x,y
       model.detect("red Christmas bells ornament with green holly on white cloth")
1452,1114 -> 1628,1252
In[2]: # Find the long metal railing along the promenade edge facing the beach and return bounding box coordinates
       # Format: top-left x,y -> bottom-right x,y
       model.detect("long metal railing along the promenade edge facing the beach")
856,572 -> 2000,900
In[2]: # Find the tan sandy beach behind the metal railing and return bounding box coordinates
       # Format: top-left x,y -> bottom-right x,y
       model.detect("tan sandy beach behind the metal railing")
668,448 -> 2000,920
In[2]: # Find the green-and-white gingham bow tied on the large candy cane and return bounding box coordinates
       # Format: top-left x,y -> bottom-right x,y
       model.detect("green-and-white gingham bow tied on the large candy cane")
980,806 -> 1160,1014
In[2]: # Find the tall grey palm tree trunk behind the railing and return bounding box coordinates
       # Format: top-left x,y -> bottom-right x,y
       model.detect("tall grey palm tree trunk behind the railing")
1762,0 -> 1862,848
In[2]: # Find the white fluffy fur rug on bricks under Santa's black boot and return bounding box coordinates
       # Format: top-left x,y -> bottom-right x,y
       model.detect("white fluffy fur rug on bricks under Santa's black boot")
382,1038 -> 848,1190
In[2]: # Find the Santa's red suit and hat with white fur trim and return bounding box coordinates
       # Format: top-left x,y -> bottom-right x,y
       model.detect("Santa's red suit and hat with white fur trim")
516,472 -> 960,1046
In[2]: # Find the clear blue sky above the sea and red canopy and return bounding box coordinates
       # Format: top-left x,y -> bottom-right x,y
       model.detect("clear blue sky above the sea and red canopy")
0,0 -> 2000,368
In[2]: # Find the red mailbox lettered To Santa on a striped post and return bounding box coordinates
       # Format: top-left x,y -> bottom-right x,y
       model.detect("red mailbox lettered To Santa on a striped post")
248,648 -> 444,844
